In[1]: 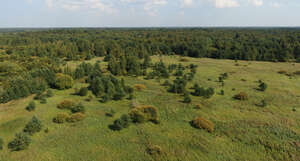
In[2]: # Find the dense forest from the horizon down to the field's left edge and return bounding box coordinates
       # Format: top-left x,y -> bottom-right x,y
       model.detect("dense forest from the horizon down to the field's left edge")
0,28 -> 300,103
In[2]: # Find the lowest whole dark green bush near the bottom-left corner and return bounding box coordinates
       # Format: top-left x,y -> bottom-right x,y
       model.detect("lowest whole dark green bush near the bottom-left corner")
8,133 -> 31,151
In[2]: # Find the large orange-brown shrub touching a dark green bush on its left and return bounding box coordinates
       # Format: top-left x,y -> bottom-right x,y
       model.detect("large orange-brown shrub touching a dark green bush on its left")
129,106 -> 158,123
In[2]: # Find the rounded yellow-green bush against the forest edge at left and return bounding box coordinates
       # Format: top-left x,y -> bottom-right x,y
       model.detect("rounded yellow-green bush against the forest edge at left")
55,73 -> 74,90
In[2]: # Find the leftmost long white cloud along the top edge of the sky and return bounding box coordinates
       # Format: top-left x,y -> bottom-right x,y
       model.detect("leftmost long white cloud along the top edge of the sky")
45,0 -> 117,14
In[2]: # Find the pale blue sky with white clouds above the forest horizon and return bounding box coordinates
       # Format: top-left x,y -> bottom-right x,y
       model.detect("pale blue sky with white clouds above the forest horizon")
0,0 -> 300,28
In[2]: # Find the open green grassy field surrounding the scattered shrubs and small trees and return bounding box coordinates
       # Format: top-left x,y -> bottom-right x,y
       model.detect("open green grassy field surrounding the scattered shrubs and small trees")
0,56 -> 300,161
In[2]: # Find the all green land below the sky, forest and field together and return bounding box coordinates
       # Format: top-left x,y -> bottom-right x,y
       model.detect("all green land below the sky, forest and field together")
0,28 -> 300,161
